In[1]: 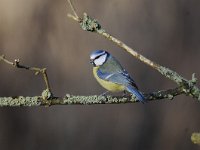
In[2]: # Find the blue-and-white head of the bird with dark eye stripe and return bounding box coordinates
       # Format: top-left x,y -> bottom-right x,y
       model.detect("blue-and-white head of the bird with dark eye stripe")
90,50 -> 110,67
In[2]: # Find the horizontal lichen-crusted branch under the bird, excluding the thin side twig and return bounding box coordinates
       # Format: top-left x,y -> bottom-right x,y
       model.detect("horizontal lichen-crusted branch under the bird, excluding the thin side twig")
0,87 -> 183,107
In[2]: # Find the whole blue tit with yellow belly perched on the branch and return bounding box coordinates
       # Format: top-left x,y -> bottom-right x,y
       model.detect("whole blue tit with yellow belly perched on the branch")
90,50 -> 145,103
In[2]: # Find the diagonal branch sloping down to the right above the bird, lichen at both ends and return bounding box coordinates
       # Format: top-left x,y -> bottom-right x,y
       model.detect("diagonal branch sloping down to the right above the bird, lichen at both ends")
68,0 -> 200,101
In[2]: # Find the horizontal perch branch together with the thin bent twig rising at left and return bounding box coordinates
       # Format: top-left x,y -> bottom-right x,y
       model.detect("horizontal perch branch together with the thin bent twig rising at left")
0,52 -> 186,107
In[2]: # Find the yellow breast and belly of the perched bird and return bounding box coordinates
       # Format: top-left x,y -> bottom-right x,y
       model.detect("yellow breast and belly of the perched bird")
93,67 -> 125,92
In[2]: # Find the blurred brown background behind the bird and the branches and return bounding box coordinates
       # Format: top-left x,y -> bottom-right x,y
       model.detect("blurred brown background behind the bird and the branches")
0,0 -> 200,150
